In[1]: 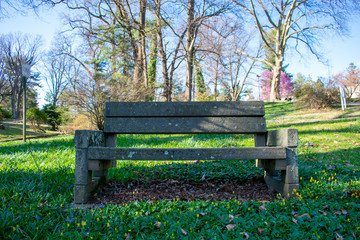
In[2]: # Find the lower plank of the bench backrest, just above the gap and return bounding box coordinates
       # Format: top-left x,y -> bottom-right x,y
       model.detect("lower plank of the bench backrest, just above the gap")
104,117 -> 266,134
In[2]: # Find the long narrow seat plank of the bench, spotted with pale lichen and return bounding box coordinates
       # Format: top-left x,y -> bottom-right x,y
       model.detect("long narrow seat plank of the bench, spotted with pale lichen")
88,147 -> 286,161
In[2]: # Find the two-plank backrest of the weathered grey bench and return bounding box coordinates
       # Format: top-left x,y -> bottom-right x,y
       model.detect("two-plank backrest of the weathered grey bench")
104,101 -> 266,134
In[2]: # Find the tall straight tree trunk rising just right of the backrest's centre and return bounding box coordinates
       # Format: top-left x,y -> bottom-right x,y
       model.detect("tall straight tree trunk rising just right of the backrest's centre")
185,0 -> 195,101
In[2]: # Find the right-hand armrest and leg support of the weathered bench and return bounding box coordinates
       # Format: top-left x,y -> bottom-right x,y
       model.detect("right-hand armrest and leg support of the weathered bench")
255,129 -> 299,198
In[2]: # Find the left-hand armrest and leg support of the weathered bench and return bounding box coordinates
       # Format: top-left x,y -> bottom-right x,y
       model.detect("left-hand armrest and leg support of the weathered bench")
74,130 -> 107,204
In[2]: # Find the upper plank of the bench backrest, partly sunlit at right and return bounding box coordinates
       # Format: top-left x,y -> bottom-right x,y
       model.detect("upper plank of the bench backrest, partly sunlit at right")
105,101 -> 265,117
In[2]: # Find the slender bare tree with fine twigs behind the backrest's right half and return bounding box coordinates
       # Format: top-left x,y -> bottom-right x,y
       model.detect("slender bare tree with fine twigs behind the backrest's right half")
197,14 -> 261,101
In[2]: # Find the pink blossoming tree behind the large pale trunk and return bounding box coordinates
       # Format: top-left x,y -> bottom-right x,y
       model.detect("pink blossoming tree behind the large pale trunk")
259,70 -> 293,101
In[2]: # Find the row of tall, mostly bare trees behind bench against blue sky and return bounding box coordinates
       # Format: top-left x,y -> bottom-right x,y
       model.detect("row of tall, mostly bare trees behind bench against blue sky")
0,0 -> 359,129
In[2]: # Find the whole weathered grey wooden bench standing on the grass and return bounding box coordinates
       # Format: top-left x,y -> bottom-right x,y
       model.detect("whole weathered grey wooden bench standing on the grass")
74,101 -> 299,204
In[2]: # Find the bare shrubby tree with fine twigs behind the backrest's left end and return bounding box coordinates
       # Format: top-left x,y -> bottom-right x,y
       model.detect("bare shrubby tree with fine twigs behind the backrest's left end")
61,14 -> 112,129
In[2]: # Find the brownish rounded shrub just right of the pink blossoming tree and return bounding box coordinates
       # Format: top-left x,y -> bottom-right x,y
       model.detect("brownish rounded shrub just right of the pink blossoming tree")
295,79 -> 340,109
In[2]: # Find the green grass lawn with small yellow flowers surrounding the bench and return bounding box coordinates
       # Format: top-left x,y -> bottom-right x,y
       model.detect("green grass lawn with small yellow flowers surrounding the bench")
0,104 -> 360,239
